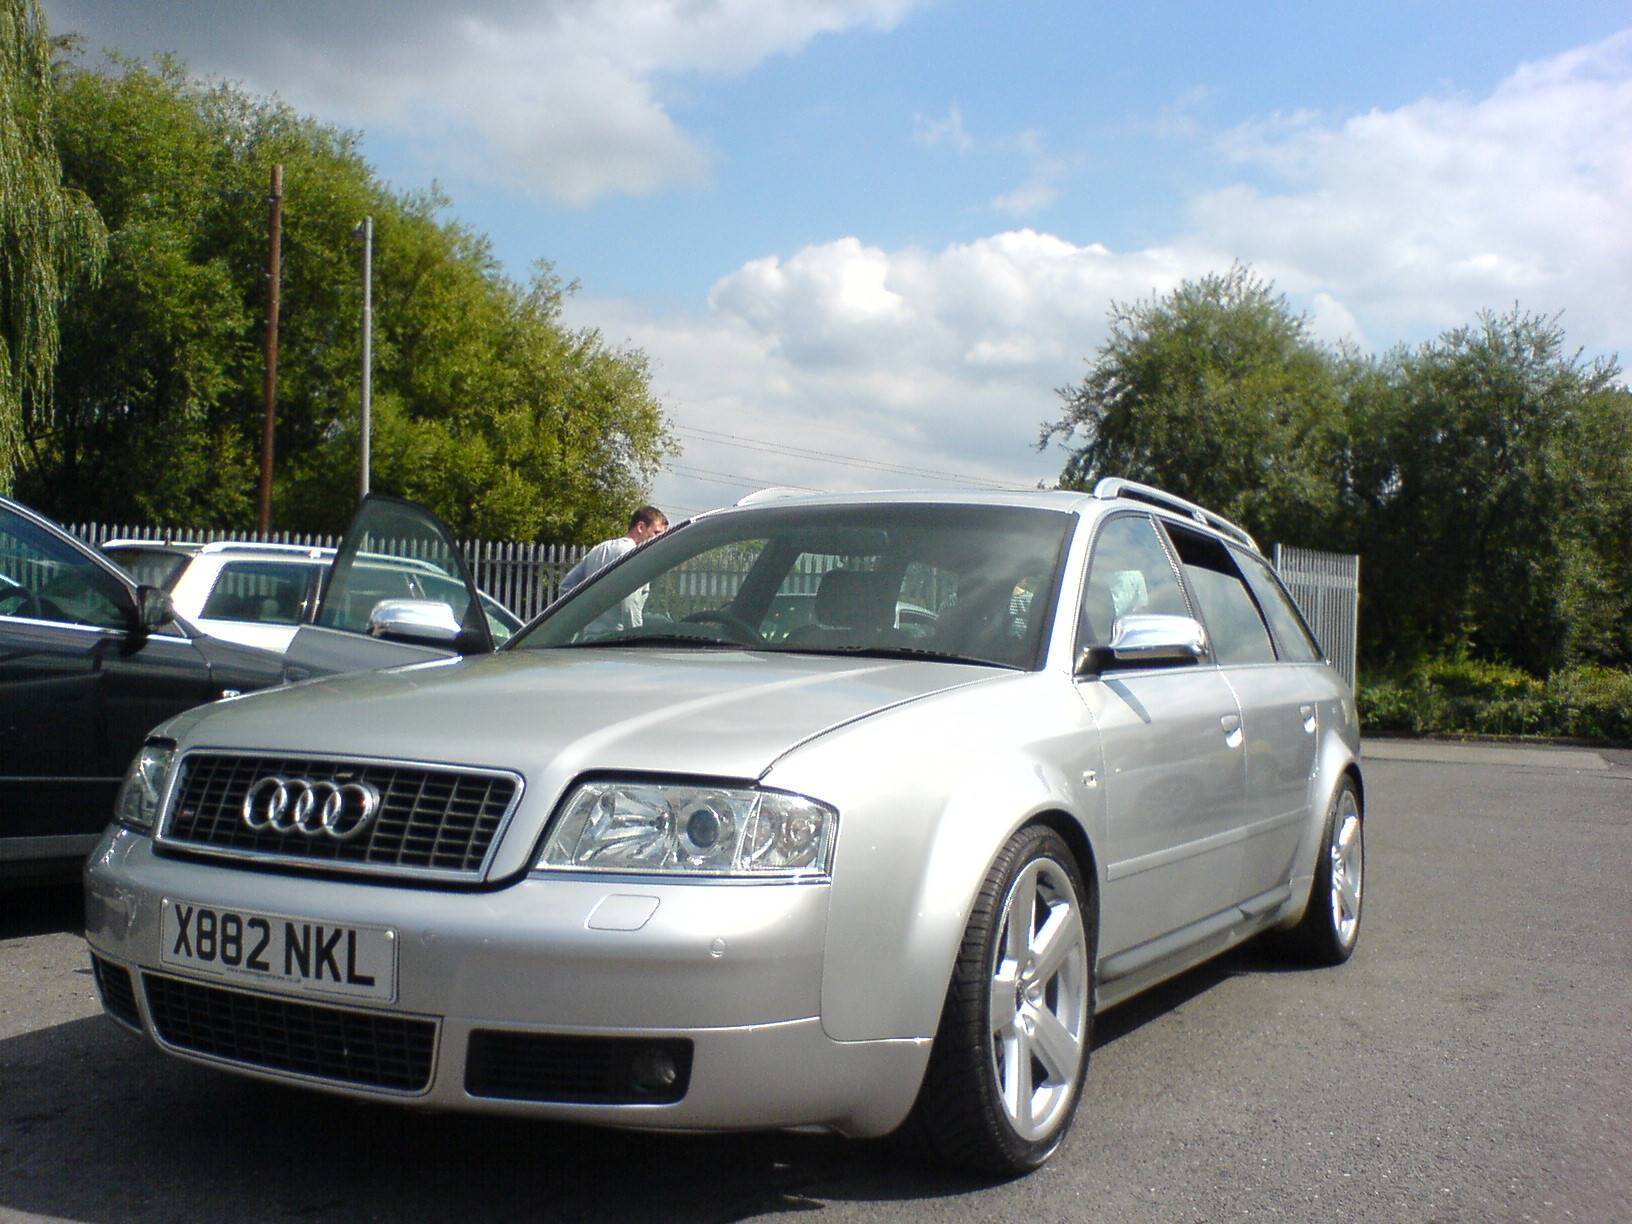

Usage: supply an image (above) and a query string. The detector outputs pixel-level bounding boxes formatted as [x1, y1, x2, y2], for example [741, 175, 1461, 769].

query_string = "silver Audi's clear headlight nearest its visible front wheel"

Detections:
[537, 782, 839, 878]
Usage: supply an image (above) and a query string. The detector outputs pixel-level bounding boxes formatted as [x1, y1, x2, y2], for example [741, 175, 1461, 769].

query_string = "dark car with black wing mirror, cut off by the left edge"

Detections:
[0, 498, 284, 878]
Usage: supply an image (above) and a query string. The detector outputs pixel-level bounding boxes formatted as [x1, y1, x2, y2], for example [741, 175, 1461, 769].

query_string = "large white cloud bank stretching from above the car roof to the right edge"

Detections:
[574, 25, 1632, 506]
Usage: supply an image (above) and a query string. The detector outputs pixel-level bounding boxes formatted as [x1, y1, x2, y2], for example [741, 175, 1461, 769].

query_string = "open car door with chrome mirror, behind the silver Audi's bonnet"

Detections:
[286, 493, 493, 679]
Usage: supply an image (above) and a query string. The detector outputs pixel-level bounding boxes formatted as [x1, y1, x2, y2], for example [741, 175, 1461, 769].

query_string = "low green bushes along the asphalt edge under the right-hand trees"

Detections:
[1356, 658, 1632, 743]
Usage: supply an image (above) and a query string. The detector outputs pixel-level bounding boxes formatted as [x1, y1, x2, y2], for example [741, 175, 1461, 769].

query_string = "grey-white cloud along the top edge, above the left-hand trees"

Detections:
[47, 0, 920, 204]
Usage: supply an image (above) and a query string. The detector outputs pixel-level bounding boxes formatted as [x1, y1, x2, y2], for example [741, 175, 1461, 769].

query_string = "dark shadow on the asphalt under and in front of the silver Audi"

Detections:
[0, 894, 1281, 1224]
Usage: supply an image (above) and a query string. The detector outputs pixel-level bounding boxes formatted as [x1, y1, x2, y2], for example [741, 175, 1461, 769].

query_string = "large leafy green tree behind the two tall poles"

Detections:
[28, 59, 672, 542]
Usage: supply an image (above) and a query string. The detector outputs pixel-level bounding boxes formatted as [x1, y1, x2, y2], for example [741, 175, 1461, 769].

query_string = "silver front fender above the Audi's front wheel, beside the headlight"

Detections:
[765, 674, 1102, 1041]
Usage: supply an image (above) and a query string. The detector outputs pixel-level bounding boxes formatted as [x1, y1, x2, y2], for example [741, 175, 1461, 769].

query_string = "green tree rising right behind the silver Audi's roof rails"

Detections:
[1040, 266, 1343, 543]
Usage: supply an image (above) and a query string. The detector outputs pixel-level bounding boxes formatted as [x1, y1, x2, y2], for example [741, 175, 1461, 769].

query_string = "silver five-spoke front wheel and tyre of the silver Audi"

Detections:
[906, 824, 1095, 1177]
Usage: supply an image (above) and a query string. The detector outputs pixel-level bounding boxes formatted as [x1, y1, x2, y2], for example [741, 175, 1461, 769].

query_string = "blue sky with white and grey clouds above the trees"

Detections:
[44, 0, 1632, 516]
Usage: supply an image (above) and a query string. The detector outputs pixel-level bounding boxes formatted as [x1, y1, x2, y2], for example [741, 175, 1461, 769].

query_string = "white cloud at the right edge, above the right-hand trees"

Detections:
[1190, 31, 1632, 348]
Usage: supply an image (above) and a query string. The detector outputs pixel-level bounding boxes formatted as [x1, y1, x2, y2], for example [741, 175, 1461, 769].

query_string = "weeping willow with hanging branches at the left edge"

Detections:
[0, 0, 106, 490]
